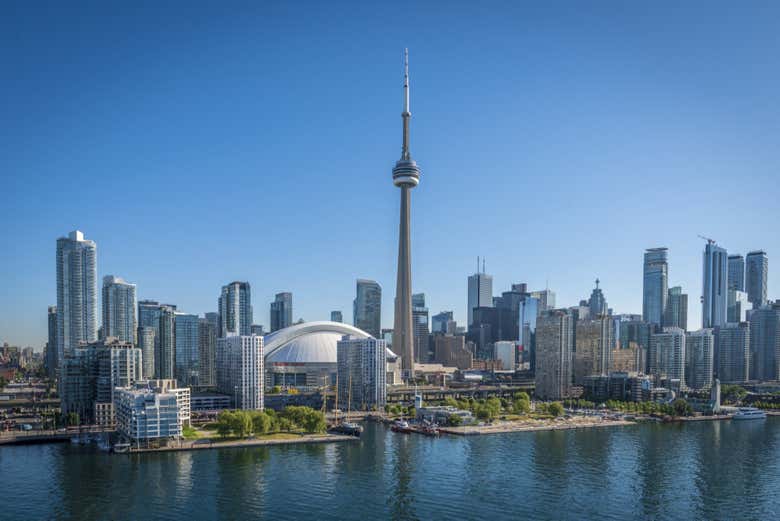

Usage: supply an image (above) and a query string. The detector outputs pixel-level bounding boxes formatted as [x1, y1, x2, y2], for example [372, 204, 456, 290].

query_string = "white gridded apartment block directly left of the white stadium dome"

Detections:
[217, 335, 265, 409]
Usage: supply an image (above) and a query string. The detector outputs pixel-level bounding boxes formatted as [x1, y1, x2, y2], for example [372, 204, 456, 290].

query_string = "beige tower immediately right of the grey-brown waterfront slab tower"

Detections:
[574, 315, 614, 385]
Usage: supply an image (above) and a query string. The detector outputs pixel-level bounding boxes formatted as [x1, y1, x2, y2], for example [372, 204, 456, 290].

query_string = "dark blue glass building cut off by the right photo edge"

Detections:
[750, 300, 780, 380]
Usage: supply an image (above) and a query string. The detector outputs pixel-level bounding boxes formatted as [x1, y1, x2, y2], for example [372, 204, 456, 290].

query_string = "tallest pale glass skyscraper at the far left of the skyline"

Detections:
[57, 230, 98, 363]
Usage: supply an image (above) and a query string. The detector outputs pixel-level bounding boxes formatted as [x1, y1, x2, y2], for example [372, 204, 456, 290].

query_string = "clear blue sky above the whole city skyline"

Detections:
[0, 2, 780, 348]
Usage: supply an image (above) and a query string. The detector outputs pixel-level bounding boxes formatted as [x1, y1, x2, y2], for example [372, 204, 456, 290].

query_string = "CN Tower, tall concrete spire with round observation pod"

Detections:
[393, 49, 420, 381]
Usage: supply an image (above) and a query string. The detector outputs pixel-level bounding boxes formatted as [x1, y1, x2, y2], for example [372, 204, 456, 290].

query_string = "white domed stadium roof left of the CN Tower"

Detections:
[263, 321, 370, 365]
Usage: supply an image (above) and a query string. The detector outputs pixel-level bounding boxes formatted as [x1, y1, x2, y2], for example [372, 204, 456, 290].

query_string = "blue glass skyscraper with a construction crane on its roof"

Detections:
[701, 239, 728, 329]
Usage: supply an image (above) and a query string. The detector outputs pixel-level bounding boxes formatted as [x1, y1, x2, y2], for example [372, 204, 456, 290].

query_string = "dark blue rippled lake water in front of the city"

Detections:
[0, 417, 780, 521]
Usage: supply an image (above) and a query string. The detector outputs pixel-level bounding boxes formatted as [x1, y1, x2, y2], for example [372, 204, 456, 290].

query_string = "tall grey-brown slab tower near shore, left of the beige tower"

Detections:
[535, 310, 574, 400]
